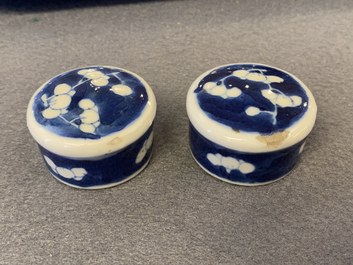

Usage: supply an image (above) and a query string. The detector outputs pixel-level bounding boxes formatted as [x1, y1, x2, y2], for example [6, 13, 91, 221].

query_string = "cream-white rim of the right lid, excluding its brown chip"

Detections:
[186, 63, 317, 153]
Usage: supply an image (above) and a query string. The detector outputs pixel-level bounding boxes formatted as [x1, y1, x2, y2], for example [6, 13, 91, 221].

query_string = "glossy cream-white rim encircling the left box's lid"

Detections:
[27, 66, 157, 159]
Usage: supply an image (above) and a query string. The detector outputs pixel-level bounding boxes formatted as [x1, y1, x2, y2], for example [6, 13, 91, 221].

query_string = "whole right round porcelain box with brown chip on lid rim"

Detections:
[186, 63, 317, 186]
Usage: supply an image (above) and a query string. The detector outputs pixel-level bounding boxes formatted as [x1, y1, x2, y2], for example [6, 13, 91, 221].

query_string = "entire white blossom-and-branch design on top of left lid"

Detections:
[41, 68, 133, 134]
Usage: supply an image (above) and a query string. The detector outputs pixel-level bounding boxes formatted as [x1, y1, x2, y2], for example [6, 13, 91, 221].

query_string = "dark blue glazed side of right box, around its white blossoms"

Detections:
[189, 123, 305, 185]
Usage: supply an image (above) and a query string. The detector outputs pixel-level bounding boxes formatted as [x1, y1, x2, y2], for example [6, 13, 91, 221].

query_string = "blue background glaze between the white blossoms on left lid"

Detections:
[33, 66, 148, 139]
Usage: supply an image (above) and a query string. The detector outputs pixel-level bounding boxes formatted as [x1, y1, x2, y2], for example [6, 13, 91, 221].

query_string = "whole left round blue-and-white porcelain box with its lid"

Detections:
[27, 66, 156, 189]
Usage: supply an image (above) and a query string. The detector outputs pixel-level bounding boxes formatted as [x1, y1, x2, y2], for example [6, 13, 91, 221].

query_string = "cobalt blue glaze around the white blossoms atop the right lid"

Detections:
[194, 64, 308, 134]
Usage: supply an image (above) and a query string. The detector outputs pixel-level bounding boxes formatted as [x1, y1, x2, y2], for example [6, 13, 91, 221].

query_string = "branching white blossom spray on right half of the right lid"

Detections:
[233, 68, 302, 124]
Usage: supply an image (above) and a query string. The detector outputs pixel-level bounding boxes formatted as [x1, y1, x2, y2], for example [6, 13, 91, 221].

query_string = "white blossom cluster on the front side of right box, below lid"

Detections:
[207, 153, 255, 174]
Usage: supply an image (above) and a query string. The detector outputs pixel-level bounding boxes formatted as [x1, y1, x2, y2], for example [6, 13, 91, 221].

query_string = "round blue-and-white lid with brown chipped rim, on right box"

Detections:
[186, 63, 317, 153]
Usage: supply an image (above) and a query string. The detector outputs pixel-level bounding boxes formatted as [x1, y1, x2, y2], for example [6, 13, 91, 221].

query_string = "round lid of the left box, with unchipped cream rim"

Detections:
[27, 66, 156, 158]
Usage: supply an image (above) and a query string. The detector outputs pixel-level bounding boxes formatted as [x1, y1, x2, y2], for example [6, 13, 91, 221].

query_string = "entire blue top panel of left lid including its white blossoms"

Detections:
[33, 67, 148, 139]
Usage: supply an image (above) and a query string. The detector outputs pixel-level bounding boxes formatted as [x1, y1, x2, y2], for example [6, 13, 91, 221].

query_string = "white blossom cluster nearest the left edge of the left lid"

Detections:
[41, 84, 75, 119]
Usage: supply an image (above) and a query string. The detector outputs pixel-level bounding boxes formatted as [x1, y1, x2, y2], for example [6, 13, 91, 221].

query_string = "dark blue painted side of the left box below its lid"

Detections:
[39, 125, 153, 188]
